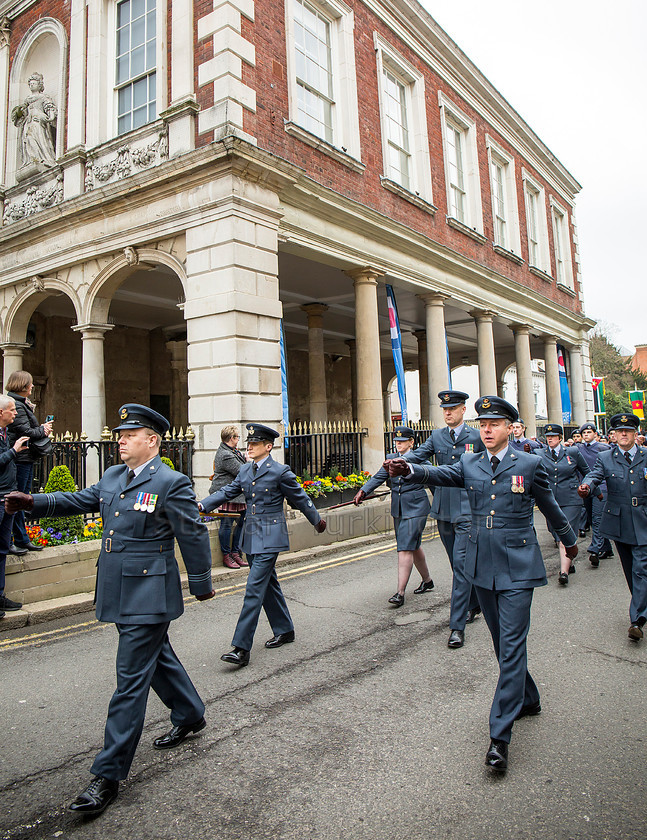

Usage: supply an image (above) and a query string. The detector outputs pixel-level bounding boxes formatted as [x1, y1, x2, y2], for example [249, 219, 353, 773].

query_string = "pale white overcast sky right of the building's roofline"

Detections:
[422, 0, 647, 353]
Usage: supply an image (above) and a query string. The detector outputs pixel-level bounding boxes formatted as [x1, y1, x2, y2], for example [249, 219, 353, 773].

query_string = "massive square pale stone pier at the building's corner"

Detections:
[184, 174, 283, 495]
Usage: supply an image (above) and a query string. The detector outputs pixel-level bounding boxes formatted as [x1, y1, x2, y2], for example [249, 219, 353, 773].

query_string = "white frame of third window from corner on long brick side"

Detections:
[438, 91, 483, 236]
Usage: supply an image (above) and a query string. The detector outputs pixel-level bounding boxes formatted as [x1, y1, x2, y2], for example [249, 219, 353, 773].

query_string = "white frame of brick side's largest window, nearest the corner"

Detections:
[285, 0, 364, 170]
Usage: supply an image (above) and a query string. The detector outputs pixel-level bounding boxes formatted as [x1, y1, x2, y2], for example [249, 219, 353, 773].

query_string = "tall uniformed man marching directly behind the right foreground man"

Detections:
[410, 391, 484, 648]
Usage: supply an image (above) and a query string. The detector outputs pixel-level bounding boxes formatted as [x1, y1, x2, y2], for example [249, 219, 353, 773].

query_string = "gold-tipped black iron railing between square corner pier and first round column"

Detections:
[284, 421, 364, 477]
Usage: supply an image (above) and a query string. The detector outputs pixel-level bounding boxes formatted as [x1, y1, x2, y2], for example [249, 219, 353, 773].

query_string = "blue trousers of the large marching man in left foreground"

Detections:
[90, 622, 204, 779]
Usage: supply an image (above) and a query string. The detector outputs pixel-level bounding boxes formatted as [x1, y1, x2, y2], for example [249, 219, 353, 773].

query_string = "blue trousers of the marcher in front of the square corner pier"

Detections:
[231, 554, 294, 650]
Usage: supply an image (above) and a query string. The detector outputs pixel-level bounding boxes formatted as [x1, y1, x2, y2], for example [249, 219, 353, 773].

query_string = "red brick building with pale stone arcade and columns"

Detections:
[0, 0, 592, 489]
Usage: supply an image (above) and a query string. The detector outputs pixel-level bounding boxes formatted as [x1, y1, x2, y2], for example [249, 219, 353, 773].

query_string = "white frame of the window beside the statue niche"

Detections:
[105, 0, 168, 140]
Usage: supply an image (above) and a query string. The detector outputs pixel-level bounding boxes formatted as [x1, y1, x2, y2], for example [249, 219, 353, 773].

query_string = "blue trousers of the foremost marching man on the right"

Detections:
[474, 586, 539, 743]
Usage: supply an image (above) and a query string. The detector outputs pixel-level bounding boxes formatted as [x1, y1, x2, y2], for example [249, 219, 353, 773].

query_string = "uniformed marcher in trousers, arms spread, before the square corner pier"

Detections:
[200, 423, 326, 666]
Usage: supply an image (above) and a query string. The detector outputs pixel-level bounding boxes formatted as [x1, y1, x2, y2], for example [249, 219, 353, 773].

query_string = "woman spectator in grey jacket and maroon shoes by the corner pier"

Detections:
[209, 426, 249, 569]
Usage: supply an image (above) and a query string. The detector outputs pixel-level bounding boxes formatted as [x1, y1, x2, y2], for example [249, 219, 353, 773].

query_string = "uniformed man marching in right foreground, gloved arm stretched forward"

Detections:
[385, 396, 577, 772]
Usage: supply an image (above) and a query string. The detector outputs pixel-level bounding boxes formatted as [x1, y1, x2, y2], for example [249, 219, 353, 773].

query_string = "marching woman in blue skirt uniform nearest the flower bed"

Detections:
[354, 426, 434, 607]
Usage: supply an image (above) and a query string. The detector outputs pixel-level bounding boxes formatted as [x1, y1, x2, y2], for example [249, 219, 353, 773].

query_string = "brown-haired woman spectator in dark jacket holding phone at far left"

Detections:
[6, 370, 52, 554]
